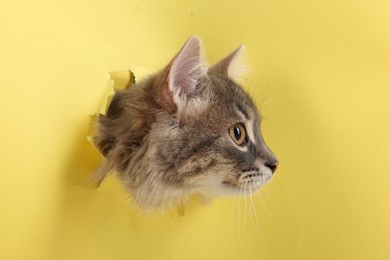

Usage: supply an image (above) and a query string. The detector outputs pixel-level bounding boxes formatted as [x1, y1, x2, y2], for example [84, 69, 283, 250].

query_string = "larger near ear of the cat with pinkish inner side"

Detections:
[168, 36, 207, 107]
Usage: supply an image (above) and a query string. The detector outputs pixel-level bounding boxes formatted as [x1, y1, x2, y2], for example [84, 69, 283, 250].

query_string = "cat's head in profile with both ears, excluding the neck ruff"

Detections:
[152, 36, 278, 195]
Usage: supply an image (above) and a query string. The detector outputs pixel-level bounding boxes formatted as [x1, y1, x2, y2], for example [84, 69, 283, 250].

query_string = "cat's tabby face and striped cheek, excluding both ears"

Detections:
[152, 75, 278, 195]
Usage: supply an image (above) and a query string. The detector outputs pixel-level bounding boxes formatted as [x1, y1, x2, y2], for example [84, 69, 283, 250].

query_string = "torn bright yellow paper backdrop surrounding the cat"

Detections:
[0, 0, 390, 259]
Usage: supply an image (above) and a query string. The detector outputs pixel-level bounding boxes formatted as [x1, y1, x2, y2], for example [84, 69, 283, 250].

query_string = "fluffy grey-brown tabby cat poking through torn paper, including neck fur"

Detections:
[93, 36, 278, 209]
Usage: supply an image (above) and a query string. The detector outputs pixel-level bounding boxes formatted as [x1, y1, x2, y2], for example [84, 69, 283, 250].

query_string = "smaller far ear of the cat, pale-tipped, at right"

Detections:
[210, 45, 249, 81]
